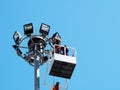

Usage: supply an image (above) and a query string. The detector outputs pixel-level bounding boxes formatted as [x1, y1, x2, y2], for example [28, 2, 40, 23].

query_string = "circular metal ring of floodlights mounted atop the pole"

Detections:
[13, 23, 50, 65]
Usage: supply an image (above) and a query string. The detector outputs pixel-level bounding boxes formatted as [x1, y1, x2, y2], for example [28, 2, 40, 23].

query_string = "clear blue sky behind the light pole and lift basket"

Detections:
[0, 0, 120, 90]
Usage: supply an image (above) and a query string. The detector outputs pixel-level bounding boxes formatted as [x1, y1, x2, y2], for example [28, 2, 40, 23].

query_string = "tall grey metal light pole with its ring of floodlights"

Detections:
[13, 23, 50, 90]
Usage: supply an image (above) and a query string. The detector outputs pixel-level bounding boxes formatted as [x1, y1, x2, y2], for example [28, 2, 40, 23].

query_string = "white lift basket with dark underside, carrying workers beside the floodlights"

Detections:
[49, 45, 76, 79]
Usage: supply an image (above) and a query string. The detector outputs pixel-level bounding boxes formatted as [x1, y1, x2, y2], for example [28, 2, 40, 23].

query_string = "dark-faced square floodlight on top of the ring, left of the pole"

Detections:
[23, 23, 33, 36]
